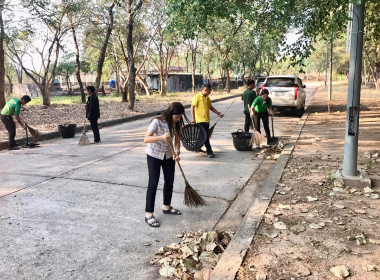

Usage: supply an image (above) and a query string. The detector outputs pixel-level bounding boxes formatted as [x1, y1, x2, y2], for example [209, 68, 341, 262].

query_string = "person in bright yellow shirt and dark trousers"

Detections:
[191, 84, 224, 158]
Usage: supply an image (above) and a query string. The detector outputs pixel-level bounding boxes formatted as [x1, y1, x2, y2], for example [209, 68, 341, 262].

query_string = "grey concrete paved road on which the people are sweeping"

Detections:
[0, 84, 313, 280]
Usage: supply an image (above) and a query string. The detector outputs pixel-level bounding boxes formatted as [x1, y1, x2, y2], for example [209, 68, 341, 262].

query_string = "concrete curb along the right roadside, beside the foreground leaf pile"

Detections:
[209, 91, 318, 280]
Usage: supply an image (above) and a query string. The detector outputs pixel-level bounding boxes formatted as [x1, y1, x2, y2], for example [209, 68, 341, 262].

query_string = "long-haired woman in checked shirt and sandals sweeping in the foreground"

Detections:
[144, 102, 185, 227]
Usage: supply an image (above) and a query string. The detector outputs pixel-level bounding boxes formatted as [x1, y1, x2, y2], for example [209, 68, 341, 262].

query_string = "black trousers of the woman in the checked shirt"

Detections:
[145, 155, 175, 213]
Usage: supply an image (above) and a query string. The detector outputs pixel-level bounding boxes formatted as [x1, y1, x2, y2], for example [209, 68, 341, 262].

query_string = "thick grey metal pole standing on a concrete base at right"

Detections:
[342, 0, 365, 176]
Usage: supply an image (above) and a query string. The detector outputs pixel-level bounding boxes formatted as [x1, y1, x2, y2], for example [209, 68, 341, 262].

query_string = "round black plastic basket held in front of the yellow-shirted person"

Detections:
[181, 124, 207, 152]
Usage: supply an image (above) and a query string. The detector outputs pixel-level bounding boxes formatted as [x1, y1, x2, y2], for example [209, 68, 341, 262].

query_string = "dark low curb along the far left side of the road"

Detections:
[0, 94, 241, 151]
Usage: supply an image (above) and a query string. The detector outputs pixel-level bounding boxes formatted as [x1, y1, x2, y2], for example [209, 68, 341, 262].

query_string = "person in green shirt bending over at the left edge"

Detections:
[0, 95, 31, 150]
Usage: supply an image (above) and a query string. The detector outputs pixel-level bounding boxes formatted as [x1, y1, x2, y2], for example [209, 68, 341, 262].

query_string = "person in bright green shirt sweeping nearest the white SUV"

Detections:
[252, 88, 273, 138]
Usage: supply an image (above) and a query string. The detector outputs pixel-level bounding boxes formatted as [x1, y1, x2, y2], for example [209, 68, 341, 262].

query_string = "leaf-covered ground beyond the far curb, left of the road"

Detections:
[0, 89, 235, 142]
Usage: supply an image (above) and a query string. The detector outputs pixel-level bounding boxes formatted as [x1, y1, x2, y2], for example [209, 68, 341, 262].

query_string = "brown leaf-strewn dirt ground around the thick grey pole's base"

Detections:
[236, 85, 380, 280]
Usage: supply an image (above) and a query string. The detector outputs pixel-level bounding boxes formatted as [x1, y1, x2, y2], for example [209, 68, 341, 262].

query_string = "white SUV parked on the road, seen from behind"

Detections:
[261, 75, 306, 116]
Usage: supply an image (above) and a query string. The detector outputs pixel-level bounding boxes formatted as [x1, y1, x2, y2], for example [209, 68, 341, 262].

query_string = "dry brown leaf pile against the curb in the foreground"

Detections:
[150, 230, 233, 280]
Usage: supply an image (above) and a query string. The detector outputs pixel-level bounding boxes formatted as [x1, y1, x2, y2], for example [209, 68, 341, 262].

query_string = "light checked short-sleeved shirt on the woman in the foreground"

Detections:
[145, 119, 173, 160]
